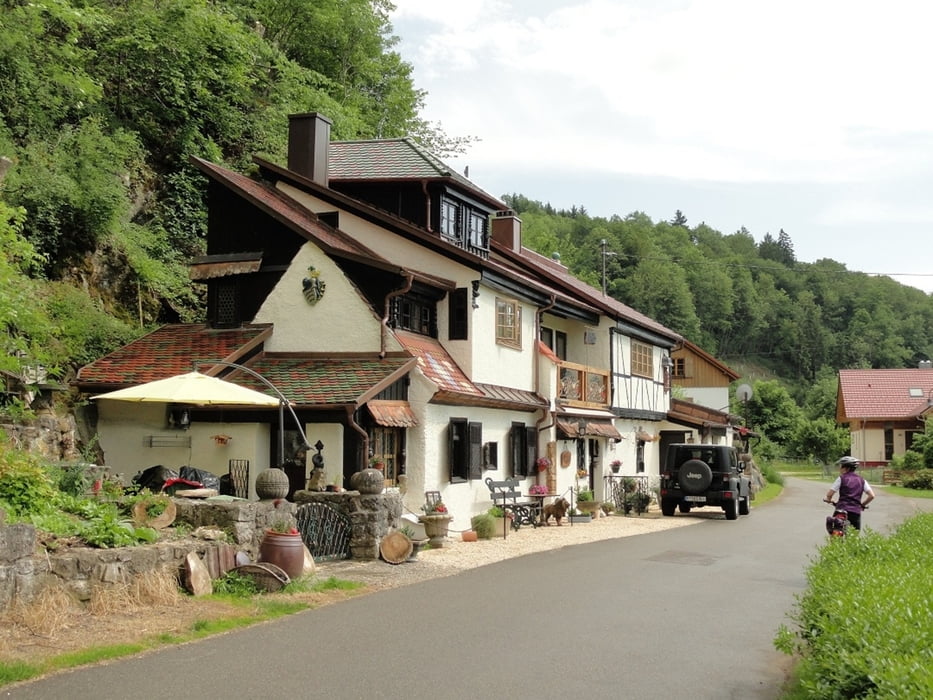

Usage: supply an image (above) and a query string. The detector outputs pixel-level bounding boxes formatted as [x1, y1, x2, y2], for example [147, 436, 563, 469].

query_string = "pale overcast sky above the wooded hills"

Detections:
[391, 0, 933, 293]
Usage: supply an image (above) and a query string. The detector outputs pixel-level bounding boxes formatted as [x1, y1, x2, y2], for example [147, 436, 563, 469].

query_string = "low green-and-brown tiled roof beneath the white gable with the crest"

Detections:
[229, 354, 415, 408]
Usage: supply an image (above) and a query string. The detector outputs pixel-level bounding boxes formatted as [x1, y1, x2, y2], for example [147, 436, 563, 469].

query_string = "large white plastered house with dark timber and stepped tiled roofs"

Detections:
[77, 114, 682, 529]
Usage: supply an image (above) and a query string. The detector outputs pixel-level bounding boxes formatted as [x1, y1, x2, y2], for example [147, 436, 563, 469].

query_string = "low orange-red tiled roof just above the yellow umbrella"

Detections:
[77, 323, 272, 391]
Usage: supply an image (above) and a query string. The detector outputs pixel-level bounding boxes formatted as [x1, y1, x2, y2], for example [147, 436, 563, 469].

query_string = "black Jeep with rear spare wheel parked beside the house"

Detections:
[661, 443, 751, 520]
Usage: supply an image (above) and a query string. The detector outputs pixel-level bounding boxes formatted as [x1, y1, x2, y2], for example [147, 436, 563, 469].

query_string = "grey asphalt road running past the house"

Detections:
[7, 479, 933, 700]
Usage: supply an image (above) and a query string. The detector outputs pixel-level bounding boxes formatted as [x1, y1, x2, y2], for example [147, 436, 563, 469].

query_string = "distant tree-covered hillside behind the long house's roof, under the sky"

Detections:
[505, 194, 933, 384]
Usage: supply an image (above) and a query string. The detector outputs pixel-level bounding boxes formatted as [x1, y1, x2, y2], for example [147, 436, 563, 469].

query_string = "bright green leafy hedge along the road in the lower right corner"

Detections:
[775, 513, 933, 698]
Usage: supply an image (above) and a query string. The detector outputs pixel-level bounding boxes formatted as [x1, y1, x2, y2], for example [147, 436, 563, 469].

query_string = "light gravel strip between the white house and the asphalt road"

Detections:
[317, 511, 701, 589]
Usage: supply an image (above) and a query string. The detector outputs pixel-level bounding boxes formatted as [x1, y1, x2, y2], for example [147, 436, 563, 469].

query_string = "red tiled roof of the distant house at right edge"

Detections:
[837, 369, 933, 421]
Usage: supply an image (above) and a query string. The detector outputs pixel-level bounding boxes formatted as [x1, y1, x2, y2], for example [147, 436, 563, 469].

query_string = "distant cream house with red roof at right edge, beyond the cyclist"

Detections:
[836, 362, 933, 467]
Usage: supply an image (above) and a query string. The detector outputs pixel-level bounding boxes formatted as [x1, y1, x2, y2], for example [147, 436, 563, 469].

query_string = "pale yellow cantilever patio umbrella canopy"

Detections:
[92, 372, 281, 407]
